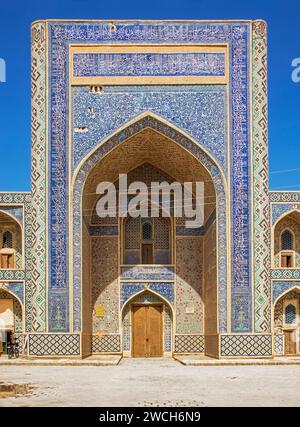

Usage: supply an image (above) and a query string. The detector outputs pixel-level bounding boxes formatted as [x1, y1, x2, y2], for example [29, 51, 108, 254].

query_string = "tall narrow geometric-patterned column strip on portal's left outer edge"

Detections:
[31, 22, 48, 332]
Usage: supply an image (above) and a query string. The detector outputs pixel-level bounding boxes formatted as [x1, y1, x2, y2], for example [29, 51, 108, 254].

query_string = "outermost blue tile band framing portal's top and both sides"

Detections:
[48, 21, 252, 331]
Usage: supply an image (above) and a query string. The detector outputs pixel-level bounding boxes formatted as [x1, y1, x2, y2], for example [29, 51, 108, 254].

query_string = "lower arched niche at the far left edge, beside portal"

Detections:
[0, 288, 23, 354]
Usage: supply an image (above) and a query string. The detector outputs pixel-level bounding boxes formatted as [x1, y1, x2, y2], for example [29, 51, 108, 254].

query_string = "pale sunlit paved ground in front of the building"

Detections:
[0, 359, 300, 406]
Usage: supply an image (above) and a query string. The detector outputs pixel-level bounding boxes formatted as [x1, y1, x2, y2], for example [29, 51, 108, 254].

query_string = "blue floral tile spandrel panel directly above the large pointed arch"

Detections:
[72, 85, 227, 173]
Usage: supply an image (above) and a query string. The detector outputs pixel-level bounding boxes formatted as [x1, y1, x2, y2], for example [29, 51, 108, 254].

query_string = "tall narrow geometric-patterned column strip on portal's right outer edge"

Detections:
[252, 21, 271, 332]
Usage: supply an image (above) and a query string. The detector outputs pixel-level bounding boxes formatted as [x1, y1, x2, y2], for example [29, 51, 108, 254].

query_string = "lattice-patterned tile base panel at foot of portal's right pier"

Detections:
[221, 334, 272, 357]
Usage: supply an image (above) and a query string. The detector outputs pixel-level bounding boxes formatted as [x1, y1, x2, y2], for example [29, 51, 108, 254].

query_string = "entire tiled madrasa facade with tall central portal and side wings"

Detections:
[0, 20, 300, 358]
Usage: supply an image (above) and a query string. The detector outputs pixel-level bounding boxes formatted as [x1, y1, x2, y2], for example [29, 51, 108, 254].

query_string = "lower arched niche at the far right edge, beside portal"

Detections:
[274, 286, 300, 356]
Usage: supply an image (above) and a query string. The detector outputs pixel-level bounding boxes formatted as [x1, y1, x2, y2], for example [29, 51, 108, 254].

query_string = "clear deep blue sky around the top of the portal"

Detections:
[0, 0, 300, 191]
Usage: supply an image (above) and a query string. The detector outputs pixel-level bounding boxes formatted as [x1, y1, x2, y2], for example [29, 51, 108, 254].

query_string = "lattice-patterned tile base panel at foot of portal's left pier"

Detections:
[29, 334, 80, 356]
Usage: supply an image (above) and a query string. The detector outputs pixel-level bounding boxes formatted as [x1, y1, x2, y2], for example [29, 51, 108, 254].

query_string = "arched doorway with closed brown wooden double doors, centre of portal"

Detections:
[122, 290, 173, 357]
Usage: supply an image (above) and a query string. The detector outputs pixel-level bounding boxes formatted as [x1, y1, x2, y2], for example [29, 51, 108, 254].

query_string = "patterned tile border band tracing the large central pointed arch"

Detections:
[69, 112, 230, 338]
